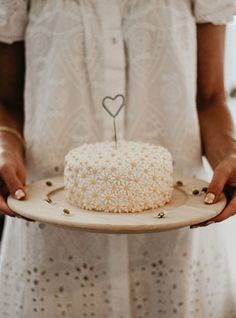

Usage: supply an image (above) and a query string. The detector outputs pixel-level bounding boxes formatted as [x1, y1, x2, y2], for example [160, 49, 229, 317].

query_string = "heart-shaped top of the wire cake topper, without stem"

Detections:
[102, 94, 125, 118]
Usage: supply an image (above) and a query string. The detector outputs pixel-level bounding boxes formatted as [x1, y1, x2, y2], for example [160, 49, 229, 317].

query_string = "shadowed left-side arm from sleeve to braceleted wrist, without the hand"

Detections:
[0, 42, 25, 151]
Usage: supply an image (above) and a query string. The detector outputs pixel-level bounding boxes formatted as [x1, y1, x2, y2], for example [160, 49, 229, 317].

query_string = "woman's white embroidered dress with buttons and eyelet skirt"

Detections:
[0, 0, 236, 318]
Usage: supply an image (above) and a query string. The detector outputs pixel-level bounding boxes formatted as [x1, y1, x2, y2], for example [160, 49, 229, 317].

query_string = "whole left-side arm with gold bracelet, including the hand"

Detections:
[0, 42, 26, 211]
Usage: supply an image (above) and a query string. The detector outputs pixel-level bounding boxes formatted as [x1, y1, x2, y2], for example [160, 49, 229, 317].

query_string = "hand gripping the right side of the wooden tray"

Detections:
[193, 155, 236, 227]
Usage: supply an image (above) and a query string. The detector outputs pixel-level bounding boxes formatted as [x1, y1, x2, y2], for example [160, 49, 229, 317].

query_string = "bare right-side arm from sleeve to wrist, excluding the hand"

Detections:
[197, 23, 236, 168]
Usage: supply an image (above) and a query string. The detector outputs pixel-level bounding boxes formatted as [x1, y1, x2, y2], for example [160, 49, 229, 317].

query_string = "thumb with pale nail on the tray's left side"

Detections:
[1, 165, 26, 200]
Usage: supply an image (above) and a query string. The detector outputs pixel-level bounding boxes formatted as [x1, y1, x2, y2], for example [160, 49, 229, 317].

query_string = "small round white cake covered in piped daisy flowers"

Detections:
[64, 141, 173, 212]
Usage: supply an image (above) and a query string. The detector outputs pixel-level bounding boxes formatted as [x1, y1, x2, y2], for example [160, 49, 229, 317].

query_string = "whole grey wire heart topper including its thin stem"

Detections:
[102, 94, 125, 148]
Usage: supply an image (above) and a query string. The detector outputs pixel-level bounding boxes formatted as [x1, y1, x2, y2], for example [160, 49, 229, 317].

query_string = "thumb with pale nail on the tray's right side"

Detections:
[204, 166, 230, 204]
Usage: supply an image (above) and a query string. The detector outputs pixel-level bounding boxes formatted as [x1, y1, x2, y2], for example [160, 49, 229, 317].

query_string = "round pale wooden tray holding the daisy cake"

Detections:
[8, 176, 226, 233]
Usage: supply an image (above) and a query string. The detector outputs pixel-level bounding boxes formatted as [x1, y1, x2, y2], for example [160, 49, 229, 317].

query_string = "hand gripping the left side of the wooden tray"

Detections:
[0, 133, 26, 217]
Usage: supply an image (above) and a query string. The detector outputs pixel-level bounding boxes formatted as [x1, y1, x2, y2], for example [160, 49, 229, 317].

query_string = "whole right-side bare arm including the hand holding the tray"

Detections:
[194, 23, 236, 227]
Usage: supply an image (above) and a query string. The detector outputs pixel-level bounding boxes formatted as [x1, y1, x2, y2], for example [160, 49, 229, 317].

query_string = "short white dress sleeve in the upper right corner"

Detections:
[194, 0, 236, 24]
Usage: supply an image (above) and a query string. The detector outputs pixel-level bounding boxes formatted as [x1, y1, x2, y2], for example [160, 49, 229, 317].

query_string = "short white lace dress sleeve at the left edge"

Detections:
[0, 0, 28, 43]
